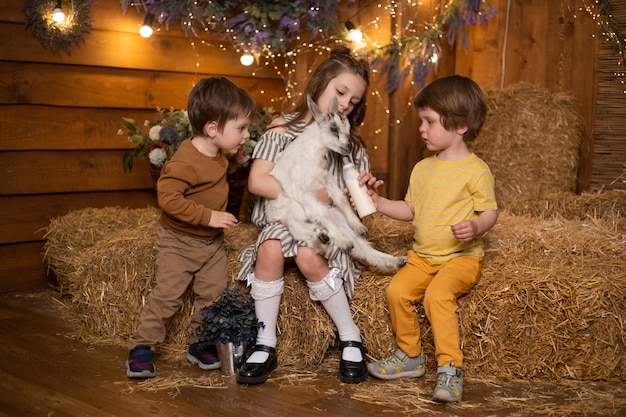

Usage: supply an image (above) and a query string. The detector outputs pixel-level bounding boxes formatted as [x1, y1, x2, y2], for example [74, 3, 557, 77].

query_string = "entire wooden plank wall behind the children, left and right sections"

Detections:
[0, 0, 621, 292]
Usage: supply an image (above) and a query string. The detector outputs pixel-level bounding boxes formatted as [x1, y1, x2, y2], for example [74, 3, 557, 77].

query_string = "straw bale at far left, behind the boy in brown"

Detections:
[44, 207, 192, 352]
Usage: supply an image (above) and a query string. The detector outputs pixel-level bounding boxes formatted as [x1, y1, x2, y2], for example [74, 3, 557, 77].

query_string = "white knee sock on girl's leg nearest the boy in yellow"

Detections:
[307, 268, 363, 362]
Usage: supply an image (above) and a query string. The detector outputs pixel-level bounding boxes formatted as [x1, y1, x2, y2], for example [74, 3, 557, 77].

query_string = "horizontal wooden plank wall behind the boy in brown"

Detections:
[0, 0, 284, 292]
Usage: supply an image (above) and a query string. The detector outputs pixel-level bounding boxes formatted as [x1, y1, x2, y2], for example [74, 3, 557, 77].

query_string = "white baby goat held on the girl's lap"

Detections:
[265, 97, 405, 270]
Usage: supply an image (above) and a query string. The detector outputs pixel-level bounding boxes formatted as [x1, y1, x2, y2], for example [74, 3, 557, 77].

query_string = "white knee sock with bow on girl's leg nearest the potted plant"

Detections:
[246, 274, 284, 363]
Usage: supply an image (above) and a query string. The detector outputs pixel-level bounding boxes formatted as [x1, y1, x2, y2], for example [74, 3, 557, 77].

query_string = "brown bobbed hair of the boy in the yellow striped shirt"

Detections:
[413, 75, 487, 142]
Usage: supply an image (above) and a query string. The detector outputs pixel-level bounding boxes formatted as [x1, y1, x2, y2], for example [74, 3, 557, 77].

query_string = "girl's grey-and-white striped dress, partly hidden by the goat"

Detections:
[237, 115, 370, 298]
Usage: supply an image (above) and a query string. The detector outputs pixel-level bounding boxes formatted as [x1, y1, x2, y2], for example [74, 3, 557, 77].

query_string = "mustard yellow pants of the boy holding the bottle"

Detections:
[386, 251, 480, 368]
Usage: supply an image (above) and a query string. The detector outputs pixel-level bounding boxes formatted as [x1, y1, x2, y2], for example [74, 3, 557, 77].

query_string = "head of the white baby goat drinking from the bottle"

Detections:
[307, 96, 352, 155]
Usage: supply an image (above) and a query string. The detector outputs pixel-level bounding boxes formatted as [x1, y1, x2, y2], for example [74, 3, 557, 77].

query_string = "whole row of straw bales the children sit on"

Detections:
[45, 190, 626, 380]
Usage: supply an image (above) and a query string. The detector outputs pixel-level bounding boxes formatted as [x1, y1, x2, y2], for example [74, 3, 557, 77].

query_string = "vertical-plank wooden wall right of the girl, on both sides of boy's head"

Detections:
[362, 0, 608, 198]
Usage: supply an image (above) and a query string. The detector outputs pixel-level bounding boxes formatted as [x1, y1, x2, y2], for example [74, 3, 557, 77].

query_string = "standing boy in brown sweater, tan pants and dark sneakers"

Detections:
[126, 77, 256, 378]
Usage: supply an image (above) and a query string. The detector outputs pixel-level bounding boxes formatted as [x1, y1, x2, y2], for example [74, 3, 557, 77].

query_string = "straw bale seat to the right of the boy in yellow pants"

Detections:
[458, 213, 626, 380]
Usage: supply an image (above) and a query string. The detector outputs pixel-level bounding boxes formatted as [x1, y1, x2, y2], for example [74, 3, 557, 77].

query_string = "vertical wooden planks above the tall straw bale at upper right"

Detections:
[456, 0, 599, 191]
